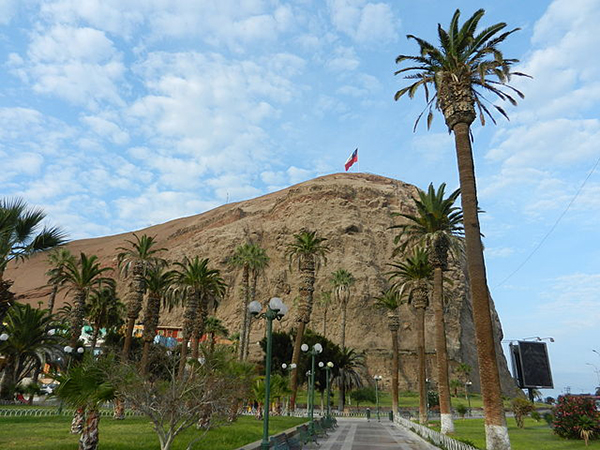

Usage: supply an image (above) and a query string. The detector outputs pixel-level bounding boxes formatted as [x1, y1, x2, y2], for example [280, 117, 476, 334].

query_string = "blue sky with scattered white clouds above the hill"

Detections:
[0, 0, 600, 395]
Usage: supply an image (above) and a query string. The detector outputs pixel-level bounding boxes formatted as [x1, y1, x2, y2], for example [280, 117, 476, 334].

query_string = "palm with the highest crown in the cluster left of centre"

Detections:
[117, 233, 166, 360]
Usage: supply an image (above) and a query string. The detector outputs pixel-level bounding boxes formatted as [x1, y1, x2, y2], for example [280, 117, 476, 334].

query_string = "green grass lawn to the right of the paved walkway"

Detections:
[432, 417, 600, 450]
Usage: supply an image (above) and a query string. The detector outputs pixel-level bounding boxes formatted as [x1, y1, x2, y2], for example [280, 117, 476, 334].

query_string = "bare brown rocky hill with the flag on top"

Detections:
[6, 174, 514, 393]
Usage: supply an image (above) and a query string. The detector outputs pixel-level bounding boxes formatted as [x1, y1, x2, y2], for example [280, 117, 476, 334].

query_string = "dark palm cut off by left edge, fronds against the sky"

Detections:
[0, 198, 66, 323]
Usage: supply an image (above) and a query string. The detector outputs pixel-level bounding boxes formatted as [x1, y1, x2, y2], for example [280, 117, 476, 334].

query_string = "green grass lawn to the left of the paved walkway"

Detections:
[0, 416, 306, 450]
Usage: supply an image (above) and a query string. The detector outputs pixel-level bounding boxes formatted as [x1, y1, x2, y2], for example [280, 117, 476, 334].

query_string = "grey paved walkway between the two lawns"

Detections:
[318, 418, 439, 450]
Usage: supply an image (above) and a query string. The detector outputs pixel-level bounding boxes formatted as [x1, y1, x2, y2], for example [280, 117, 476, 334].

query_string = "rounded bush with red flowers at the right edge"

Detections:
[552, 395, 600, 439]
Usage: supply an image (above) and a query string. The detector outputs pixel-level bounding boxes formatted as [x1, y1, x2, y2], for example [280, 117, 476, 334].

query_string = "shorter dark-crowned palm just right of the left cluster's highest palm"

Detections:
[140, 263, 175, 374]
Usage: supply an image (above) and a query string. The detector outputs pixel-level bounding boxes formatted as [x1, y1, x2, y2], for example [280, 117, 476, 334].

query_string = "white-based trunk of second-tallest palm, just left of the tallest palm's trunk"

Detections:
[432, 266, 454, 434]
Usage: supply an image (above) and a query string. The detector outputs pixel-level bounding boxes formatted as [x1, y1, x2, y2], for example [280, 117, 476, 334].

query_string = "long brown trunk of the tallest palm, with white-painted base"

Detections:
[453, 123, 511, 450]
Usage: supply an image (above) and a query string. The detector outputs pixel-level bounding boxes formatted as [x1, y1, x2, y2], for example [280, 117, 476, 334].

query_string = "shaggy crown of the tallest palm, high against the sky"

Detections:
[394, 9, 527, 129]
